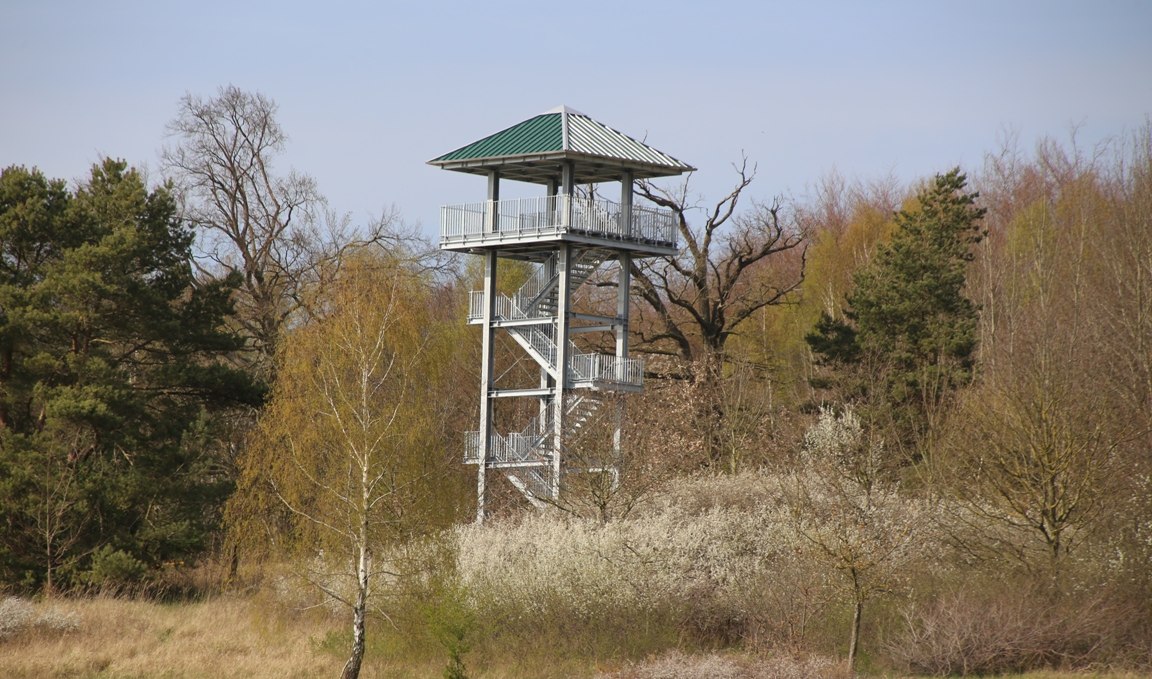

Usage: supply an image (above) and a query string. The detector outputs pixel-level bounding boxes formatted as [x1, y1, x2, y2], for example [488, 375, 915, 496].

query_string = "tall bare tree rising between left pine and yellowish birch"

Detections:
[164, 85, 405, 372]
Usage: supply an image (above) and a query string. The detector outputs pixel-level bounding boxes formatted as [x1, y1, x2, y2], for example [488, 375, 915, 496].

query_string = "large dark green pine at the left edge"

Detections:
[0, 159, 260, 593]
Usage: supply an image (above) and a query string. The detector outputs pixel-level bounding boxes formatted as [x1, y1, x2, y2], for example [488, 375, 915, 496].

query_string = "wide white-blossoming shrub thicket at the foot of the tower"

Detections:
[454, 465, 857, 647]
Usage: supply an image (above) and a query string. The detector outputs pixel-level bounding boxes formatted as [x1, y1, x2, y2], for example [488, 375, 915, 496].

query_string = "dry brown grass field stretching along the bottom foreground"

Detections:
[0, 595, 1152, 679]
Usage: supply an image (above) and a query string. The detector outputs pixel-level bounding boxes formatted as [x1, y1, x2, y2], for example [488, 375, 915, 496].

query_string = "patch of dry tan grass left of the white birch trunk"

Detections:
[0, 598, 341, 679]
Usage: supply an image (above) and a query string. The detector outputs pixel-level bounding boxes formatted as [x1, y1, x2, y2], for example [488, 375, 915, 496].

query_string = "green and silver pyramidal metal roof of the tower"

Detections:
[429, 106, 695, 183]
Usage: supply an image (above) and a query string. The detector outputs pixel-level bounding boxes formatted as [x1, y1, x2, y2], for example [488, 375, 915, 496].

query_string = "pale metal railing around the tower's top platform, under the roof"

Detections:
[440, 195, 676, 247]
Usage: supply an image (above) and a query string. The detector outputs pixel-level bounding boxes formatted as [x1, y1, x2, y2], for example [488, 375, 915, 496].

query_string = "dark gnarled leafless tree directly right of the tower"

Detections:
[631, 161, 806, 463]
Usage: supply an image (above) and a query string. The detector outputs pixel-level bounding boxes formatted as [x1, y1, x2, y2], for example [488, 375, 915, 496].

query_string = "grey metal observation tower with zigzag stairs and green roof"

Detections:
[429, 106, 695, 522]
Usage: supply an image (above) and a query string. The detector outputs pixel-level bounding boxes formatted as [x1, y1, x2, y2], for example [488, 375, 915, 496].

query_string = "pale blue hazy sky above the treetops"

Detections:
[0, 0, 1152, 235]
